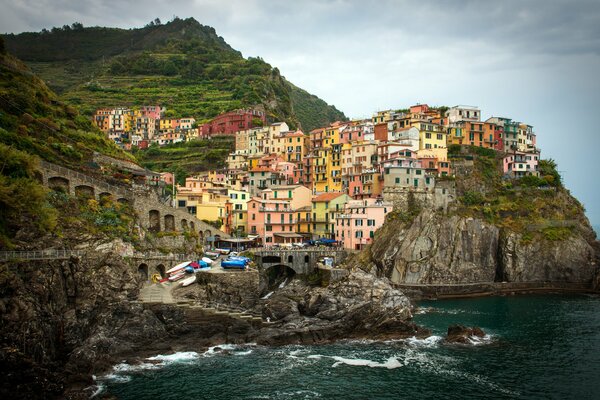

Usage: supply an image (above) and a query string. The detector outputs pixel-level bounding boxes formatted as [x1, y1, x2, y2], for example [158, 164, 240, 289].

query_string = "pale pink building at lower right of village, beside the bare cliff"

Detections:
[335, 199, 393, 250]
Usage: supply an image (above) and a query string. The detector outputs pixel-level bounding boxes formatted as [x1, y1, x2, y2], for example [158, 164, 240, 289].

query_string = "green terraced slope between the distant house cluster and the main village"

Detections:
[134, 136, 235, 184]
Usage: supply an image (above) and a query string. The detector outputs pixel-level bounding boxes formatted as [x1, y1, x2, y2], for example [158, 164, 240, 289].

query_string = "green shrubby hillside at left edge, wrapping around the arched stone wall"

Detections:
[0, 40, 142, 249]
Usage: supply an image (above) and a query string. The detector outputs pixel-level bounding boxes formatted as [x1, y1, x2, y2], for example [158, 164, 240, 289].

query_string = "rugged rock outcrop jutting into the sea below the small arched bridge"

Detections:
[257, 270, 429, 344]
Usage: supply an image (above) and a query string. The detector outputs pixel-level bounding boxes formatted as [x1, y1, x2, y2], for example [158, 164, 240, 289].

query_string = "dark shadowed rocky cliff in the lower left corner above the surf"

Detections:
[0, 252, 164, 398]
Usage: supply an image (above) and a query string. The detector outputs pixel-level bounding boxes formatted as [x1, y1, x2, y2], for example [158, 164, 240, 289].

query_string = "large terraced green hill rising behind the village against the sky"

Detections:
[4, 18, 346, 131]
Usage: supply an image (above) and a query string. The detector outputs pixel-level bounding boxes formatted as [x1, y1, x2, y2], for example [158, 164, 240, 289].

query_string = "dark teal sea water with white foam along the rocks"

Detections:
[99, 295, 600, 399]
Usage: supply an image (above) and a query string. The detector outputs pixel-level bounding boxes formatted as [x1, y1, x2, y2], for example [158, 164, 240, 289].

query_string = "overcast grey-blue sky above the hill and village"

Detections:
[0, 0, 600, 226]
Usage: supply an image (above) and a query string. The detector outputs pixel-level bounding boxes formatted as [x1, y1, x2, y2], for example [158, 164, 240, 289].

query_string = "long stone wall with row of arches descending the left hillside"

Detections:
[38, 161, 230, 240]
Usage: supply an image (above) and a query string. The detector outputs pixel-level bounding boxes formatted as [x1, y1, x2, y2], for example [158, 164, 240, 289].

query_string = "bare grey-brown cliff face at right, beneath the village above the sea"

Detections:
[370, 210, 596, 284]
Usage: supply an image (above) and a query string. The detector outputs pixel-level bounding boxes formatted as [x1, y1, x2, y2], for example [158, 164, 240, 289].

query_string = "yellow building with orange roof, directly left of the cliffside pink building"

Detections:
[311, 193, 350, 239]
